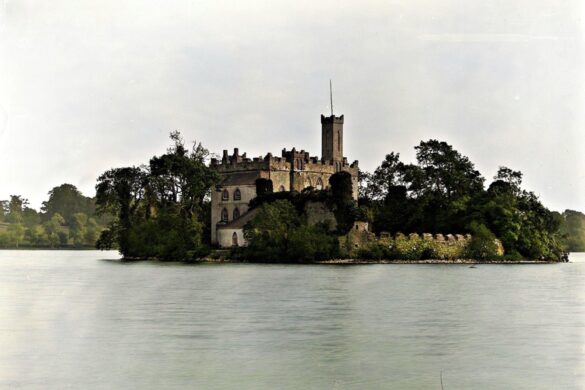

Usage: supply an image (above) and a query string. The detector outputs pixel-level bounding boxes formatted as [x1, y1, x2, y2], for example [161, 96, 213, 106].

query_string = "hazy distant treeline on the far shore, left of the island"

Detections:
[0, 184, 111, 248]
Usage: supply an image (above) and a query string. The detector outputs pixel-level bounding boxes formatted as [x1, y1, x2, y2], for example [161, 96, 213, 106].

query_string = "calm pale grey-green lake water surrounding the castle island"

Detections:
[0, 251, 585, 390]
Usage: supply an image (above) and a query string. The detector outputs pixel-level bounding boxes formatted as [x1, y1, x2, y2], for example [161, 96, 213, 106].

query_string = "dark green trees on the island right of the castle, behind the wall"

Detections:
[360, 140, 563, 259]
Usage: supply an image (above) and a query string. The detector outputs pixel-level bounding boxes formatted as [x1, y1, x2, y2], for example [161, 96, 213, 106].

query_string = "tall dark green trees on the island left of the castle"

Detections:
[96, 132, 218, 260]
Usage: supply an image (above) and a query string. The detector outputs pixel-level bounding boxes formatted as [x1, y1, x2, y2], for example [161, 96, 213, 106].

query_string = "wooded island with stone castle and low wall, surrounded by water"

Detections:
[89, 115, 568, 263]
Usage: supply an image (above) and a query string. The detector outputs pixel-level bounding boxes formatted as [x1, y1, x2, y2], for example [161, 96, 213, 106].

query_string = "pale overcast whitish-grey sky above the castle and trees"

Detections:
[0, 0, 585, 211]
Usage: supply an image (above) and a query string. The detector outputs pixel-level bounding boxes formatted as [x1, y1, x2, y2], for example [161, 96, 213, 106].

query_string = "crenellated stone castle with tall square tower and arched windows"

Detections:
[211, 115, 358, 247]
